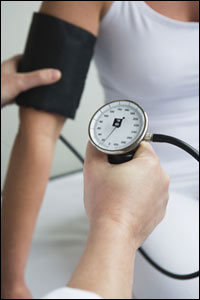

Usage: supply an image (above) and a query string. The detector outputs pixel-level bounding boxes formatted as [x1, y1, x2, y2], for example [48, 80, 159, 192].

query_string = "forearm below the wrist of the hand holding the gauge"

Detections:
[68, 222, 136, 299]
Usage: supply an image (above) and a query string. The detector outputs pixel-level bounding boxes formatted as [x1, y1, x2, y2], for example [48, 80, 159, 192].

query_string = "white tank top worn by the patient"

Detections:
[94, 1, 199, 181]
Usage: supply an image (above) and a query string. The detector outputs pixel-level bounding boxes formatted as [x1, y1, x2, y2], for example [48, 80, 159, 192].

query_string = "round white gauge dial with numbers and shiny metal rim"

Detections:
[89, 100, 148, 154]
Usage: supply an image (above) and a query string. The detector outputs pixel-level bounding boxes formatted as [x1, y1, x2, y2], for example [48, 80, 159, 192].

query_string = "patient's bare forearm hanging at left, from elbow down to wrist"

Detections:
[1, 134, 55, 284]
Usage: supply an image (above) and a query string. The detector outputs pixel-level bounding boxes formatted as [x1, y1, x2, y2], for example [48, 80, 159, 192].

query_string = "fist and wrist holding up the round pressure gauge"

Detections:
[68, 142, 169, 299]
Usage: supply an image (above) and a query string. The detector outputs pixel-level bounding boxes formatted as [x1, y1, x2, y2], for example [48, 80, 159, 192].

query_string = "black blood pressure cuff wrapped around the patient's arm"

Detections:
[16, 13, 96, 119]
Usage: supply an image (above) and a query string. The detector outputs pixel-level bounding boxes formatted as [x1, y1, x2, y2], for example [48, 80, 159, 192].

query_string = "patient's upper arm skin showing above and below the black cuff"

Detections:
[20, 1, 104, 139]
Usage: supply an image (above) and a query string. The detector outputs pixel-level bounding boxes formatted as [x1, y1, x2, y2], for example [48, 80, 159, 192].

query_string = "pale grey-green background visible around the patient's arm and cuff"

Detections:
[1, 1, 103, 187]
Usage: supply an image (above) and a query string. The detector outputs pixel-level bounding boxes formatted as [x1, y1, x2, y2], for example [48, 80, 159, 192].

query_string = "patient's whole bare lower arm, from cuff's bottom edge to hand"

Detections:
[1, 108, 65, 299]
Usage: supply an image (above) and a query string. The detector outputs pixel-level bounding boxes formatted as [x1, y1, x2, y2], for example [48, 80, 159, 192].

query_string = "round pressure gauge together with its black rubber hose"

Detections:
[88, 100, 199, 280]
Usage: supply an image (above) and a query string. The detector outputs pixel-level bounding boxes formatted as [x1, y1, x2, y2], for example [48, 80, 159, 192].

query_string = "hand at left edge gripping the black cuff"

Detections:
[1, 55, 61, 107]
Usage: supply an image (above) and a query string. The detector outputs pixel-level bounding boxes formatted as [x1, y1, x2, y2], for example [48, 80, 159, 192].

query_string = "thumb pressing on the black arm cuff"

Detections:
[17, 69, 61, 92]
